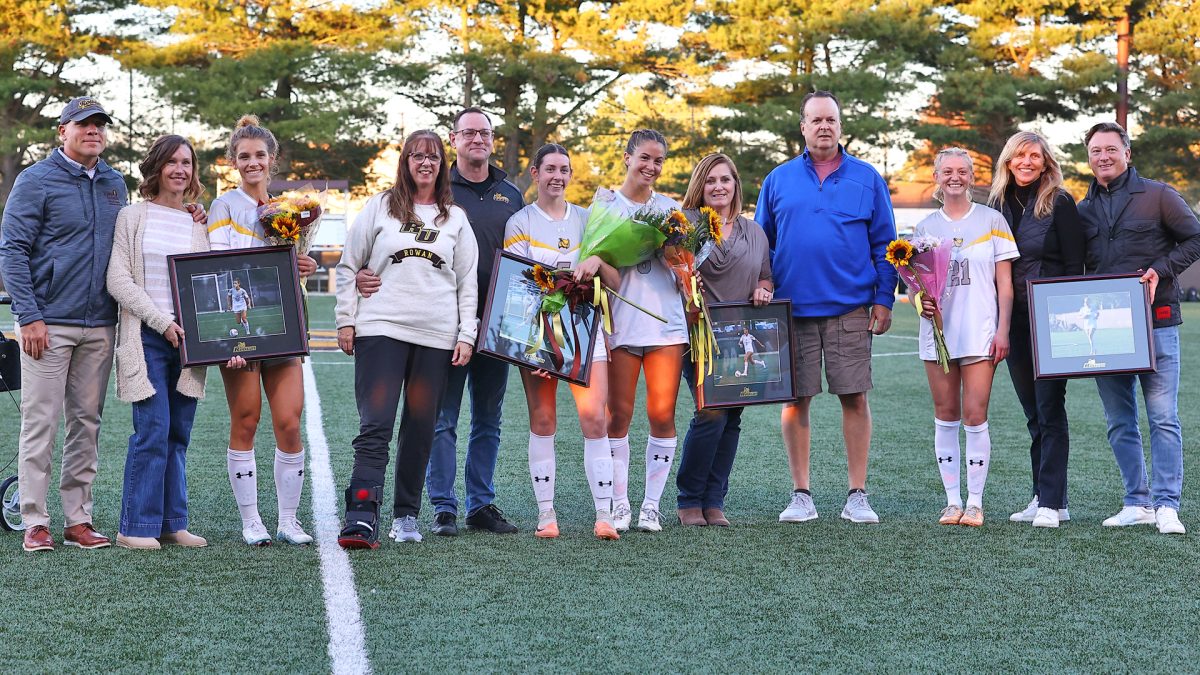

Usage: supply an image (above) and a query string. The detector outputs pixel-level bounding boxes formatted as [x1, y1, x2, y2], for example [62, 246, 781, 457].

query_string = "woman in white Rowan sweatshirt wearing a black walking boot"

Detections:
[337, 130, 479, 549]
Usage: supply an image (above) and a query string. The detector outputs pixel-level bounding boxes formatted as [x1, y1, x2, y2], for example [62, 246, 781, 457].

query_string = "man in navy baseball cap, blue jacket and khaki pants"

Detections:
[0, 96, 205, 551]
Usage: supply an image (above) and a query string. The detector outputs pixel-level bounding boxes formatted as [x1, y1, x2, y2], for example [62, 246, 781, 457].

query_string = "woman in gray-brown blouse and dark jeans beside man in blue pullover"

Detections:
[676, 154, 774, 526]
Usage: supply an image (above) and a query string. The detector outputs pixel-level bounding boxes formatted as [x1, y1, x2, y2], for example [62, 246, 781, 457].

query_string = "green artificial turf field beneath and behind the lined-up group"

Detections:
[0, 298, 1200, 674]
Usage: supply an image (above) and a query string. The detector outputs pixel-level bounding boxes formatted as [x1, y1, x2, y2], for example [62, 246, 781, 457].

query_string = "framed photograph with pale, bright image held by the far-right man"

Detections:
[1026, 273, 1156, 380]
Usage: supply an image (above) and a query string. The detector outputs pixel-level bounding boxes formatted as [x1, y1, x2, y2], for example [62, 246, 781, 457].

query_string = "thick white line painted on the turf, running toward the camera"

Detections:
[304, 360, 371, 675]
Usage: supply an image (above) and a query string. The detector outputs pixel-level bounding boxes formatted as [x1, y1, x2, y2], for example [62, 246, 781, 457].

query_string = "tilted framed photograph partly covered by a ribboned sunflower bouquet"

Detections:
[475, 251, 604, 387]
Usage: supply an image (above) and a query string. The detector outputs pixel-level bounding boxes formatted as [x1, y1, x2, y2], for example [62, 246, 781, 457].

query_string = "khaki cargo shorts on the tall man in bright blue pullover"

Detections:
[792, 307, 874, 396]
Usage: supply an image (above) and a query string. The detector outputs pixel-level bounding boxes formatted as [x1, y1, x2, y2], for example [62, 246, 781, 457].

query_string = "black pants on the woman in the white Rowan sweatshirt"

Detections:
[352, 335, 452, 518]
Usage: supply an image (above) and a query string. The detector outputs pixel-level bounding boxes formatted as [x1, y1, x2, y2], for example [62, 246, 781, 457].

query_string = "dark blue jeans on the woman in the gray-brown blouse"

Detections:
[676, 357, 745, 510]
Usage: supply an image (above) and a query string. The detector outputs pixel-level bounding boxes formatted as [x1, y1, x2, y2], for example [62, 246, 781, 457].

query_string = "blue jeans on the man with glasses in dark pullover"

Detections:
[425, 354, 509, 515]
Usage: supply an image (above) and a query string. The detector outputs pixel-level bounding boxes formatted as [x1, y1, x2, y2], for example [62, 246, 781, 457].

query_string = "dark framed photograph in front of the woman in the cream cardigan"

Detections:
[167, 246, 308, 368]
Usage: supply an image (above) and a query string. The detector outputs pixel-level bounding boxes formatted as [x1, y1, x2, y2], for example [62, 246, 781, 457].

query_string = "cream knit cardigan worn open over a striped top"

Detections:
[108, 202, 209, 402]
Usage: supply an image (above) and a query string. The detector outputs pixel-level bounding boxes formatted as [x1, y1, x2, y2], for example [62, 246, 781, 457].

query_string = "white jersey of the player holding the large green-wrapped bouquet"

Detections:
[611, 191, 688, 348]
